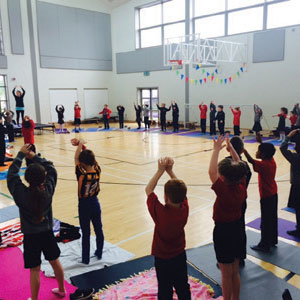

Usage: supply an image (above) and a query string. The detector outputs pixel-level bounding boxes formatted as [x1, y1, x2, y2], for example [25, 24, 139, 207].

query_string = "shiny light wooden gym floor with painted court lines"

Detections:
[0, 124, 300, 288]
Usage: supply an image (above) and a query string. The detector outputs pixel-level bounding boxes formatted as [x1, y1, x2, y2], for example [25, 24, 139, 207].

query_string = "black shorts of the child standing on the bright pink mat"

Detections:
[23, 230, 60, 269]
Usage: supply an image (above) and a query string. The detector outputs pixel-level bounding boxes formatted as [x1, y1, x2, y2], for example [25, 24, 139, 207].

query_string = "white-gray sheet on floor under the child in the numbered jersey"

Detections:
[19, 236, 135, 280]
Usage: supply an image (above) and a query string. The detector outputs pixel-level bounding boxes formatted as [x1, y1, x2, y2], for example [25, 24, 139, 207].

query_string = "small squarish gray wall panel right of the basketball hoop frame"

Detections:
[253, 29, 285, 63]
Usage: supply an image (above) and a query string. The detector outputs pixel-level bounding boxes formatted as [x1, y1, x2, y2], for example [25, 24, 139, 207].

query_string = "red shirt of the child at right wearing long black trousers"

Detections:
[254, 158, 277, 198]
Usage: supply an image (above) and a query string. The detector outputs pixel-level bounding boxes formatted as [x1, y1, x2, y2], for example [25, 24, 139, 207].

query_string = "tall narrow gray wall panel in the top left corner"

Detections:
[7, 0, 24, 54]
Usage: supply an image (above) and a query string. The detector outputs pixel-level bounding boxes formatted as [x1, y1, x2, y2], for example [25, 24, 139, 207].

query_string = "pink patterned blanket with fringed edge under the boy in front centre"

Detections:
[95, 269, 223, 300]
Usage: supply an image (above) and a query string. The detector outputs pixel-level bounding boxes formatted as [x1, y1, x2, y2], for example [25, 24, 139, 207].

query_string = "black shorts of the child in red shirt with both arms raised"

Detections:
[213, 219, 245, 264]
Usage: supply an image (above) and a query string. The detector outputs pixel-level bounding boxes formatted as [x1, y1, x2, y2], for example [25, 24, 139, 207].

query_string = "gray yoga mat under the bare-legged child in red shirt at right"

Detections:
[187, 244, 300, 300]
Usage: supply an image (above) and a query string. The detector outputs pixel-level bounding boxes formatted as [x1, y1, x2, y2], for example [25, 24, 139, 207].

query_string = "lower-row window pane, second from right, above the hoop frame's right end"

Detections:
[228, 7, 264, 34]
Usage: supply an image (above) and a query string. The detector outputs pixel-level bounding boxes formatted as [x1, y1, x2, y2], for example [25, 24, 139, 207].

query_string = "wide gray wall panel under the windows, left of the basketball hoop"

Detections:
[116, 46, 169, 74]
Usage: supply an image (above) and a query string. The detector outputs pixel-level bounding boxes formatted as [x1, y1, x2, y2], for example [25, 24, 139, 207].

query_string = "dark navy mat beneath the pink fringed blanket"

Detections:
[71, 256, 222, 297]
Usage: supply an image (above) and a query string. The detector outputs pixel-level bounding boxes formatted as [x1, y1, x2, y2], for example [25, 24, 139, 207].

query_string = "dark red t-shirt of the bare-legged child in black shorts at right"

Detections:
[211, 178, 247, 223]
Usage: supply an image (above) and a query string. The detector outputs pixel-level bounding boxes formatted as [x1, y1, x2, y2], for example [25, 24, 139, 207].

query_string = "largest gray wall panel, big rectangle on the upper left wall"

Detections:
[37, 1, 112, 71]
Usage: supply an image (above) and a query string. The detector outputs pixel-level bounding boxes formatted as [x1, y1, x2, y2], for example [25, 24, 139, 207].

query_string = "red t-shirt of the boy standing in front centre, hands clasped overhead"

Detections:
[147, 193, 189, 259]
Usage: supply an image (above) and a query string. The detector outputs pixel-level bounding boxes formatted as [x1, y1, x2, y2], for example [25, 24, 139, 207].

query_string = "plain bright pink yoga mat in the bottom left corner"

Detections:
[0, 247, 76, 300]
